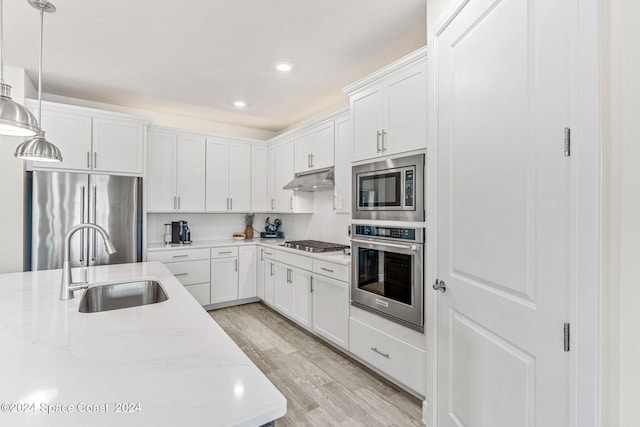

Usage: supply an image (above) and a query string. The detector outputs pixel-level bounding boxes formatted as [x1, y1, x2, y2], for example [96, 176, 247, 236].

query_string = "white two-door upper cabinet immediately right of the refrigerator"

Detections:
[147, 128, 205, 212]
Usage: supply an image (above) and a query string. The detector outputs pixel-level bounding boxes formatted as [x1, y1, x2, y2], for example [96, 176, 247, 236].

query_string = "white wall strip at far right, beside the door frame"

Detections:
[601, 0, 640, 427]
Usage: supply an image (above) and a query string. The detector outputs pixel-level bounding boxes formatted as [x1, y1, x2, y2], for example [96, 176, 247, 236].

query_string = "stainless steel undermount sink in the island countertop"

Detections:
[79, 280, 169, 313]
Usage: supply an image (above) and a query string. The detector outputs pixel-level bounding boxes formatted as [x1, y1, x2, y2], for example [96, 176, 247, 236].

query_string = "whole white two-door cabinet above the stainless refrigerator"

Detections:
[27, 100, 149, 175]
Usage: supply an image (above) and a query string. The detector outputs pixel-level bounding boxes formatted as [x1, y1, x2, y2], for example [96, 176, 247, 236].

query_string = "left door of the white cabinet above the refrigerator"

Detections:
[33, 106, 92, 171]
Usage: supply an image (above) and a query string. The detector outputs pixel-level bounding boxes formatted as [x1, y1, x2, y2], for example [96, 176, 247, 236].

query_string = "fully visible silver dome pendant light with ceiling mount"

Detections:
[14, 0, 62, 162]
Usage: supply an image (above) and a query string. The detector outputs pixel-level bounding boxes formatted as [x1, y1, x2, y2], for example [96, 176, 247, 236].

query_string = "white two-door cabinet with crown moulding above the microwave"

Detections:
[346, 48, 427, 161]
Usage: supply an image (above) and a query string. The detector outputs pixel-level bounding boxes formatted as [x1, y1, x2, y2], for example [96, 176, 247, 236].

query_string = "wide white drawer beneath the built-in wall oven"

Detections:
[349, 318, 426, 394]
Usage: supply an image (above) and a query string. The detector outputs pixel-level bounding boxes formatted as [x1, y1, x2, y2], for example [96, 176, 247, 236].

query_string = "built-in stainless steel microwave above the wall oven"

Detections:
[351, 154, 425, 221]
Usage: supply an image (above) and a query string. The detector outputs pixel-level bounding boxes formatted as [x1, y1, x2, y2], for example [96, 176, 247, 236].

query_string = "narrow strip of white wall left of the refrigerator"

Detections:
[0, 67, 30, 273]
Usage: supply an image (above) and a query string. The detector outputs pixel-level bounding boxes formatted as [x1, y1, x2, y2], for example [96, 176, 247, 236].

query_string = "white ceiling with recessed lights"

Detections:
[4, 0, 426, 132]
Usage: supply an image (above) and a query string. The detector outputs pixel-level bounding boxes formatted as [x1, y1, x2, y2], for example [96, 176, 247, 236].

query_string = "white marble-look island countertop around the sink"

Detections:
[0, 263, 287, 427]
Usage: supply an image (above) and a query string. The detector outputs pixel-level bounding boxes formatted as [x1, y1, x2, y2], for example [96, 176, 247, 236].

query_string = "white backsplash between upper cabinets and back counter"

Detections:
[147, 191, 351, 245]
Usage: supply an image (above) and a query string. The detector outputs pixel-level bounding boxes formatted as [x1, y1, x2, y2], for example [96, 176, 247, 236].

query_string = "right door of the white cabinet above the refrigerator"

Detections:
[93, 117, 144, 175]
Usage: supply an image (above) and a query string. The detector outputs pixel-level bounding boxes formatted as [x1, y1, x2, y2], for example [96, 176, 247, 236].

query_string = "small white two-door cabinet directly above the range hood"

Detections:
[295, 120, 334, 173]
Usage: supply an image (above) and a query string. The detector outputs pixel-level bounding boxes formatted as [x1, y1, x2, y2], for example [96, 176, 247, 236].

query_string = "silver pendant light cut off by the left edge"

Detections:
[0, 0, 40, 136]
